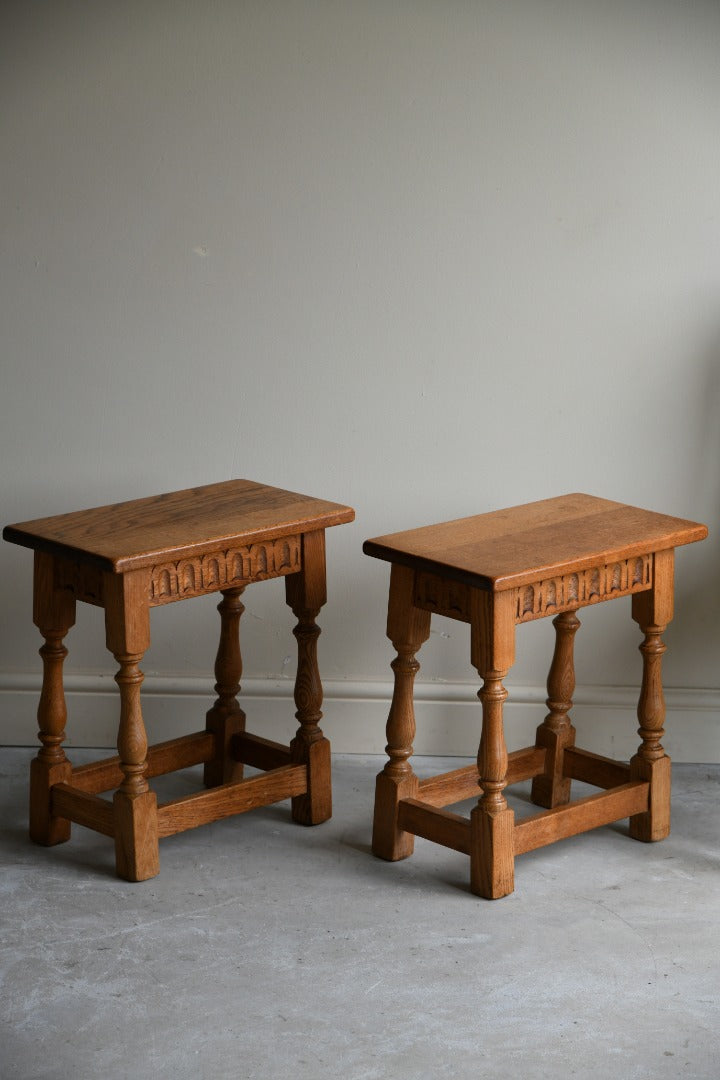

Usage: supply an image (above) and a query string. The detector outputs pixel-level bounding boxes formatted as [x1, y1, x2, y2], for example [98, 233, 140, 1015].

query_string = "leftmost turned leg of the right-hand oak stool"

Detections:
[372, 564, 430, 861]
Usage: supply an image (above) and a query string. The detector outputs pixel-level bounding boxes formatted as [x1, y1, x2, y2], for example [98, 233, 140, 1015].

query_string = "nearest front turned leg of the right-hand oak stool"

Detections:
[470, 592, 515, 900]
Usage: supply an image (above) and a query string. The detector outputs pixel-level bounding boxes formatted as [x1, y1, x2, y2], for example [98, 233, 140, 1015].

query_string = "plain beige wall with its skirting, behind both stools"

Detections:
[0, 0, 720, 760]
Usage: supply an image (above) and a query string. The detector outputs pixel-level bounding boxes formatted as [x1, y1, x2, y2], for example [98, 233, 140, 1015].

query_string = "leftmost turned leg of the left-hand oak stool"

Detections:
[30, 552, 76, 847]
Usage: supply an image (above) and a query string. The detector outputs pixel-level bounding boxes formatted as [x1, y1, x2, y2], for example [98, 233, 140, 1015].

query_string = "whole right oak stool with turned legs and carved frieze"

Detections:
[364, 495, 707, 900]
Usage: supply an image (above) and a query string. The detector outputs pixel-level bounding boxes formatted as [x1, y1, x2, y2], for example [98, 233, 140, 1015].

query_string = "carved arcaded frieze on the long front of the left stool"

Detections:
[150, 536, 302, 605]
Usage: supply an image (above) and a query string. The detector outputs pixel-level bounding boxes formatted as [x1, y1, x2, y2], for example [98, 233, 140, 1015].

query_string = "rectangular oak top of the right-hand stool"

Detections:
[363, 495, 707, 592]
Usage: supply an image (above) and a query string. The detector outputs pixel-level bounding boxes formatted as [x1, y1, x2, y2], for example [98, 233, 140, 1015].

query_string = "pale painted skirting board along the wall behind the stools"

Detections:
[0, 674, 720, 764]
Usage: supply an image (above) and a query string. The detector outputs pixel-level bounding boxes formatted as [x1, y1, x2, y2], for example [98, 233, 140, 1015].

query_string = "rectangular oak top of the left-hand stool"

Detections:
[2, 480, 355, 573]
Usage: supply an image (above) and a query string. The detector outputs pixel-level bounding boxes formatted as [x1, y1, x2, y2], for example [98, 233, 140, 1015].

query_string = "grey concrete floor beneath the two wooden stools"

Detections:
[0, 750, 720, 1080]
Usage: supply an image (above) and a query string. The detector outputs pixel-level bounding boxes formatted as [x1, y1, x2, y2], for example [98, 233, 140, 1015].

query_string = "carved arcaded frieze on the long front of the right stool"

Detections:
[515, 555, 652, 622]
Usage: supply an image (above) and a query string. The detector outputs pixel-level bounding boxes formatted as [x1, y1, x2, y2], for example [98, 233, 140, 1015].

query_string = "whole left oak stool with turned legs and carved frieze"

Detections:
[3, 480, 354, 881]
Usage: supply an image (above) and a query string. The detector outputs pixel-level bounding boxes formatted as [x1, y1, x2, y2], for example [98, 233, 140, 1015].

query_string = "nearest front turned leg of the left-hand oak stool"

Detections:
[105, 570, 160, 881]
